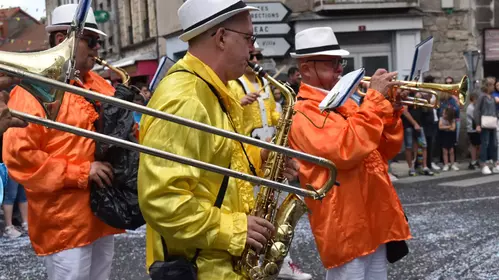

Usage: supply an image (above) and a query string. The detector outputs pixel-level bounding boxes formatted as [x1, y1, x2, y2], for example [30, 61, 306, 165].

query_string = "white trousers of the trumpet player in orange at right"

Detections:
[326, 244, 388, 280]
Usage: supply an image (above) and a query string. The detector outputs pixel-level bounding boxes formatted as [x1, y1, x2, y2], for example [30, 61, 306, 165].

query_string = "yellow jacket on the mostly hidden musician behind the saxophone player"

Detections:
[229, 75, 280, 140]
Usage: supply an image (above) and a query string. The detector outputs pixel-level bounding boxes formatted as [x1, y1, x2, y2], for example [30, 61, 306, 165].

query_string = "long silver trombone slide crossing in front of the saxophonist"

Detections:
[0, 63, 336, 200]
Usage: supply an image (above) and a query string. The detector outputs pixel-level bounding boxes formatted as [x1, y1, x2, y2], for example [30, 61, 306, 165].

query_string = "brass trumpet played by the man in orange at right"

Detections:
[359, 76, 468, 109]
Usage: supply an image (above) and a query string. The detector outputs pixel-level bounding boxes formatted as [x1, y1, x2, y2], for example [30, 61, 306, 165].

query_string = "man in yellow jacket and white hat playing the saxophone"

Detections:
[138, 0, 297, 280]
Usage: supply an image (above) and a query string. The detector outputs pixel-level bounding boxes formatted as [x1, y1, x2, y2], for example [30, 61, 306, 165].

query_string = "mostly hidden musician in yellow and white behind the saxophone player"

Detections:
[229, 42, 280, 140]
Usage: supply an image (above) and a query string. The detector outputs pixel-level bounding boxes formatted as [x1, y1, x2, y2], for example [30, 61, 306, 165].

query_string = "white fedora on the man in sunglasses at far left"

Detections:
[45, 4, 107, 36]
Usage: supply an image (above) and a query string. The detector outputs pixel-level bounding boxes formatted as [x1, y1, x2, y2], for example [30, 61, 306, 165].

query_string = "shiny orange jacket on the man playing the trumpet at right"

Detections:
[289, 83, 411, 269]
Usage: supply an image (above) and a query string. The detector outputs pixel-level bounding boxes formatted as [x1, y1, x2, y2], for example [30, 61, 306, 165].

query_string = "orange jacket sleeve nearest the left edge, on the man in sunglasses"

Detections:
[3, 87, 90, 192]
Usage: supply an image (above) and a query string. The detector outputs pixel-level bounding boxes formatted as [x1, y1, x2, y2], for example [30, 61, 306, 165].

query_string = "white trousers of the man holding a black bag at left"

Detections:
[43, 235, 114, 280]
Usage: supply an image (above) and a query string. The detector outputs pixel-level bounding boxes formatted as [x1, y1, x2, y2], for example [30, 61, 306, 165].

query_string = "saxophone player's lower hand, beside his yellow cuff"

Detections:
[246, 216, 275, 252]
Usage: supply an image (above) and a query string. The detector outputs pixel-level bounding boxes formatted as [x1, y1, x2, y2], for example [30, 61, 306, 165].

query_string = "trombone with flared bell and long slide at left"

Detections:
[0, 44, 336, 199]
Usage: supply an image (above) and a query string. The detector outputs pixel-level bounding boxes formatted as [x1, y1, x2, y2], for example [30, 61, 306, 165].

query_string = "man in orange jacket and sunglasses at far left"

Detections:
[3, 4, 124, 280]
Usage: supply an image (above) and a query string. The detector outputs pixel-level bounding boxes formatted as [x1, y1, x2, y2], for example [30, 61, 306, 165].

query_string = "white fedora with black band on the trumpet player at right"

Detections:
[291, 27, 350, 58]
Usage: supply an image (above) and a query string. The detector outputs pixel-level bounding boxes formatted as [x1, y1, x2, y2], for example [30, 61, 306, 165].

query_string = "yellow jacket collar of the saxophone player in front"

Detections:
[168, 52, 243, 111]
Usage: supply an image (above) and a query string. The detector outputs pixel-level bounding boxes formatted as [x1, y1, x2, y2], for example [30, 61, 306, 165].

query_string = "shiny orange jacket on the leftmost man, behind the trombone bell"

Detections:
[3, 72, 124, 256]
